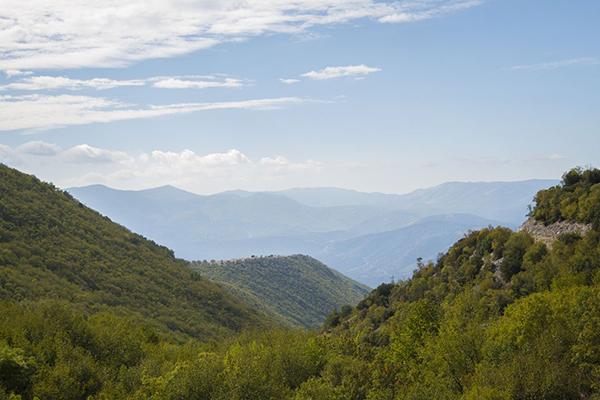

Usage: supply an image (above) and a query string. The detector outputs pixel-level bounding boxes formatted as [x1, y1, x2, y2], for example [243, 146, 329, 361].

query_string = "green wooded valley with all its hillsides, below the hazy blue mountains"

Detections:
[0, 166, 600, 400]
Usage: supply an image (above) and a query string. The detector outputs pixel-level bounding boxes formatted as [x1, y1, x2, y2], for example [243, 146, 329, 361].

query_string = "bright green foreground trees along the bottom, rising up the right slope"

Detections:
[0, 167, 600, 400]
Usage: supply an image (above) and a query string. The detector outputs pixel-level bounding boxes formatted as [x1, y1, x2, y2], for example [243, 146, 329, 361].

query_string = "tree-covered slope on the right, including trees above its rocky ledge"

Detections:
[297, 170, 600, 400]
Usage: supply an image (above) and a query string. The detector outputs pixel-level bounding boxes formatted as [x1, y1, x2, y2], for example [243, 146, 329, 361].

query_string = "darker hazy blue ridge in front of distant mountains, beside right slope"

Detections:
[322, 214, 500, 286]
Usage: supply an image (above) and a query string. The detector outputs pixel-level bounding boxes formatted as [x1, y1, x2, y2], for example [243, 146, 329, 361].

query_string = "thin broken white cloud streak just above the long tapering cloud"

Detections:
[0, 75, 248, 91]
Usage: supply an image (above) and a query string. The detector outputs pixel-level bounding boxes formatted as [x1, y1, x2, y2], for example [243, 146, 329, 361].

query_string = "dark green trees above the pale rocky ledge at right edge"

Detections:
[531, 168, 600, 229]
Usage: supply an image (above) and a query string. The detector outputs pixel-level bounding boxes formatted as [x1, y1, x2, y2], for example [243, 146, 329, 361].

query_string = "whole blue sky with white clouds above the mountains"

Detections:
[0, 0, 600, 193]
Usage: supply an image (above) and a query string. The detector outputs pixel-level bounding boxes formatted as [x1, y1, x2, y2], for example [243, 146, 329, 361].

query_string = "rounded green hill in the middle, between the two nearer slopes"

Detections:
[191, 255, 370, 328]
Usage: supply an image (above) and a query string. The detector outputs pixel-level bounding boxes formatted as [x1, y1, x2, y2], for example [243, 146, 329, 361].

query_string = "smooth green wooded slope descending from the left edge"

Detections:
[0, 165, 266, 339]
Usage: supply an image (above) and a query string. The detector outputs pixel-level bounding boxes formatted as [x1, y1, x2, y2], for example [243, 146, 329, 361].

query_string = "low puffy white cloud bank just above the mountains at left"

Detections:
[0, 141, 323, 193]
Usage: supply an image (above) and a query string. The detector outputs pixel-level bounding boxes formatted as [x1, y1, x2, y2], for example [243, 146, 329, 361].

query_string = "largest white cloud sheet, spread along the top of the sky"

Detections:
[0, 0, 479, 70]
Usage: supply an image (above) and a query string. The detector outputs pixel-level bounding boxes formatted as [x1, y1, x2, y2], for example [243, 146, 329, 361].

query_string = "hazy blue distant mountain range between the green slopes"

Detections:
[68, 180, 558, 286]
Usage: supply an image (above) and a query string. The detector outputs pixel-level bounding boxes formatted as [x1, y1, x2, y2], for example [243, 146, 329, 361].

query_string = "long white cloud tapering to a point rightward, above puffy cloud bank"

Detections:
[0, 94, 305, 131]
